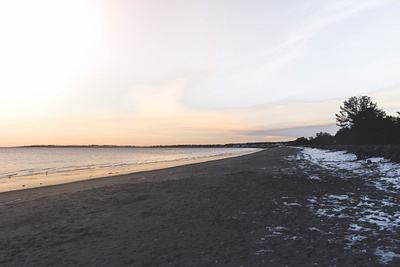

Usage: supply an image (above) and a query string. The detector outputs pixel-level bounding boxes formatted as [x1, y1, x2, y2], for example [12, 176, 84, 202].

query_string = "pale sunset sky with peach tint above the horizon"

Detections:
[0, 0, 400, 146]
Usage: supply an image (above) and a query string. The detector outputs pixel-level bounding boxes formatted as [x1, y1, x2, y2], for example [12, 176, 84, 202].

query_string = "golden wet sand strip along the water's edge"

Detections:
[0, 150, 262, 193]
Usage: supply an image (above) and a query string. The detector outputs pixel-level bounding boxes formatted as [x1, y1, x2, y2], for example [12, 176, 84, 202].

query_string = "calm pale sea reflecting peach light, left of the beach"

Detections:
[0, 147, 259, 178]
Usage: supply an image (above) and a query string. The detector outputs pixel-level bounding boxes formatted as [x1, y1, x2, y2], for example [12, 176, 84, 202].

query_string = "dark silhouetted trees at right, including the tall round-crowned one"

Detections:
[289, 96, 400, 161]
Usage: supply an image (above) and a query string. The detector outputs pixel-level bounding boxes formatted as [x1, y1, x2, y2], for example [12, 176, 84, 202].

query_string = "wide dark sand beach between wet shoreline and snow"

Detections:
[0, 148, 399, 267]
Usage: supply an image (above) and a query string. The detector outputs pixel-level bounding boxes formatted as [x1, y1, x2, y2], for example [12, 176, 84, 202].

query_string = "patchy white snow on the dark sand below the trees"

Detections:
[286, 148, 400, 264]
